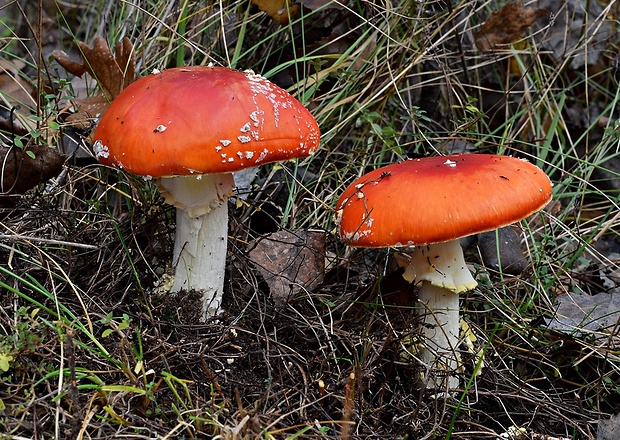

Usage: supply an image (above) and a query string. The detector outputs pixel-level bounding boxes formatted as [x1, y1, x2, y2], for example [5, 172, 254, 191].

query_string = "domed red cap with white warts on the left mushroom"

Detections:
[94, 66, 320, 177]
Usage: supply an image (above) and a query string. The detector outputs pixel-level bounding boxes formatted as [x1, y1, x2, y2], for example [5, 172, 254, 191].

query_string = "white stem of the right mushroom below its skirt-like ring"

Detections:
[418, 281, 459, 390]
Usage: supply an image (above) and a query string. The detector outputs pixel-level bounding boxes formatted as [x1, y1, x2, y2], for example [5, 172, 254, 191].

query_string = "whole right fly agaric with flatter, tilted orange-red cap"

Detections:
[336, 154, 552, 389]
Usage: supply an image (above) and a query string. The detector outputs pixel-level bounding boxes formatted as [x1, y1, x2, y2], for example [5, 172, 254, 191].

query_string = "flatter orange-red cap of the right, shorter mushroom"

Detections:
[336, 154, 552, 247]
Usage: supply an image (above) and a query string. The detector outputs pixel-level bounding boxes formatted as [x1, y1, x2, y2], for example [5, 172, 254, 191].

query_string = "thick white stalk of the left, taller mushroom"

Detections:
[158, 173, 234, 321]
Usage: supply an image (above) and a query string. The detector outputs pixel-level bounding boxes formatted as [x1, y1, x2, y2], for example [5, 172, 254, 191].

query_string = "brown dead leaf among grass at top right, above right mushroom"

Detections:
[474, 2, 549, 53]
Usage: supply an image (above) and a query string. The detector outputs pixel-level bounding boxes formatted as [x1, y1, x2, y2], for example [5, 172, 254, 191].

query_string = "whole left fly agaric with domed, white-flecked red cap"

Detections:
[93, 66, 320, 320]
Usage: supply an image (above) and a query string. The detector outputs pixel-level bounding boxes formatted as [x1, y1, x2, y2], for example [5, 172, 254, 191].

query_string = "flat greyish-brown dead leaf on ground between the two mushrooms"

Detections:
[249, 231, 325, 307]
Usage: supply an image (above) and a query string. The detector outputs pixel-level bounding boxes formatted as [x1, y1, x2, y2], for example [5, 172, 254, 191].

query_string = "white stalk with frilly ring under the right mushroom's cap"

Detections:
[403, 240, 477, 390]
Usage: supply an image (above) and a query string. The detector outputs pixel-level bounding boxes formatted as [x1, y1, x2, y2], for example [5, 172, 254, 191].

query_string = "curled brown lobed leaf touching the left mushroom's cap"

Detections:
[53, 37, 136, 128]
